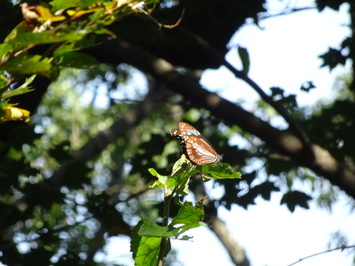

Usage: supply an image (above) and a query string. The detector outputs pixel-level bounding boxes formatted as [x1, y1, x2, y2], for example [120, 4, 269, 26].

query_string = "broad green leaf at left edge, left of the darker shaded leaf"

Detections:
[0, 55, 58, 79]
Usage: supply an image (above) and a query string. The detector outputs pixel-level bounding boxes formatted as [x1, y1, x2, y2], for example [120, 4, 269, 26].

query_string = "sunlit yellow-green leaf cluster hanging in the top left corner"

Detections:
[0, 0, 154, 121]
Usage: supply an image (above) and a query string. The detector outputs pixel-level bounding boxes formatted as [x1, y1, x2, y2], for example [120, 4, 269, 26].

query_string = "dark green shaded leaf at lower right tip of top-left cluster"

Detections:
[56, 52, 98, 69]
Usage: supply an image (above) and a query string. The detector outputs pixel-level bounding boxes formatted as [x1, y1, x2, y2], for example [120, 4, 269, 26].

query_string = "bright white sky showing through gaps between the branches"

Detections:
[96, 0, 355, 266]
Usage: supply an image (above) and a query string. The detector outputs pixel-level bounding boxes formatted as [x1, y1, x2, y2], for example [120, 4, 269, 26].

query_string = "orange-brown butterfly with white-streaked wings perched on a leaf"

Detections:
[170, 122, 223, 165]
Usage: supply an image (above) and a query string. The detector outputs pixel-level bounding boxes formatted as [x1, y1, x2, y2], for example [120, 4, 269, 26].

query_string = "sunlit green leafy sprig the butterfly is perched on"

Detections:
[131, 155, 241, 265]
